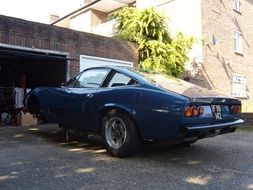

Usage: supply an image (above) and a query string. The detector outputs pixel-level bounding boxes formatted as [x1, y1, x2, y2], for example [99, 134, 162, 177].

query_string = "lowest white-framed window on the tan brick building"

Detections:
[232, 74, 247, 98]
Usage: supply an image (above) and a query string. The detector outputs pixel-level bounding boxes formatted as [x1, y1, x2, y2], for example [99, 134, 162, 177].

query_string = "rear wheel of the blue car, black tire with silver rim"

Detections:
[102, 110, 142, 158]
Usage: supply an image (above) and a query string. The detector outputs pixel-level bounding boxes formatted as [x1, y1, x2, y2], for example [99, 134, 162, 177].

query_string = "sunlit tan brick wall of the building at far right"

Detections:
[201, 0, 253, 105]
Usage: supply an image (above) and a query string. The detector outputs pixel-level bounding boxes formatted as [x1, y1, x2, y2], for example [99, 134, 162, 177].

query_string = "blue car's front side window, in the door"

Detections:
[75, 69, 108, 88]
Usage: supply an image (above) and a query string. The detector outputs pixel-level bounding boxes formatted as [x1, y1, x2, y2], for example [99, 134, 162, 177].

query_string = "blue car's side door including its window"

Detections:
[60, 68, 109, 128]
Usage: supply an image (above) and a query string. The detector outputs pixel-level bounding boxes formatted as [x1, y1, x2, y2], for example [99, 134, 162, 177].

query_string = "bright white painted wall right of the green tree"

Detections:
[136, 0, 202, 62]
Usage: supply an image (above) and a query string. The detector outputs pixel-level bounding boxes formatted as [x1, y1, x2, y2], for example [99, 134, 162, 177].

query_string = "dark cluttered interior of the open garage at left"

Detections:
[0, 47, 67, 126]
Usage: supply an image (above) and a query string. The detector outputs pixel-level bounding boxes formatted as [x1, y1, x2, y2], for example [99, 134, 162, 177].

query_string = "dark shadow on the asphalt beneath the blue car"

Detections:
[23, 125, 223, 162]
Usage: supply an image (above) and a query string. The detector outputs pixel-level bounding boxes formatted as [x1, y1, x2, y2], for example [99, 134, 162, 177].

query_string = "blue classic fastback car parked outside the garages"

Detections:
[25, 66, 244, 157]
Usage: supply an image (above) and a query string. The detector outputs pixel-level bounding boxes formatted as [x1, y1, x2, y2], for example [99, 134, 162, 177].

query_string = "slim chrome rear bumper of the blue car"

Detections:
[185, 119, 244, 131]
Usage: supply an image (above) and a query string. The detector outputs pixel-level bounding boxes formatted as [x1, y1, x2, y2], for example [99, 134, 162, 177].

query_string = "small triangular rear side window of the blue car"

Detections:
[108, 72, 137, 87]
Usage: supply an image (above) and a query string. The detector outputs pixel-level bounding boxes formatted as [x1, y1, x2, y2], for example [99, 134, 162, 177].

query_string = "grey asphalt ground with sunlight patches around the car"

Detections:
[0, 126, 253, 190]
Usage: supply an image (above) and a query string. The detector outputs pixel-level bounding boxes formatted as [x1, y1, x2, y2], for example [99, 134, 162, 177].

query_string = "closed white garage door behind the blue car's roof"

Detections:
[80, 55, 133, 71]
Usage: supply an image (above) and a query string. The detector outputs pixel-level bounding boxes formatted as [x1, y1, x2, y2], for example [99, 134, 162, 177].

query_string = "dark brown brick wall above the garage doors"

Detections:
[0, 15, 137, 76]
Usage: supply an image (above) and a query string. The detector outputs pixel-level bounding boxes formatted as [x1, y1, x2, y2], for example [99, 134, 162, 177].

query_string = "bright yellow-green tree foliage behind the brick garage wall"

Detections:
[112, 7, 194, 77]
